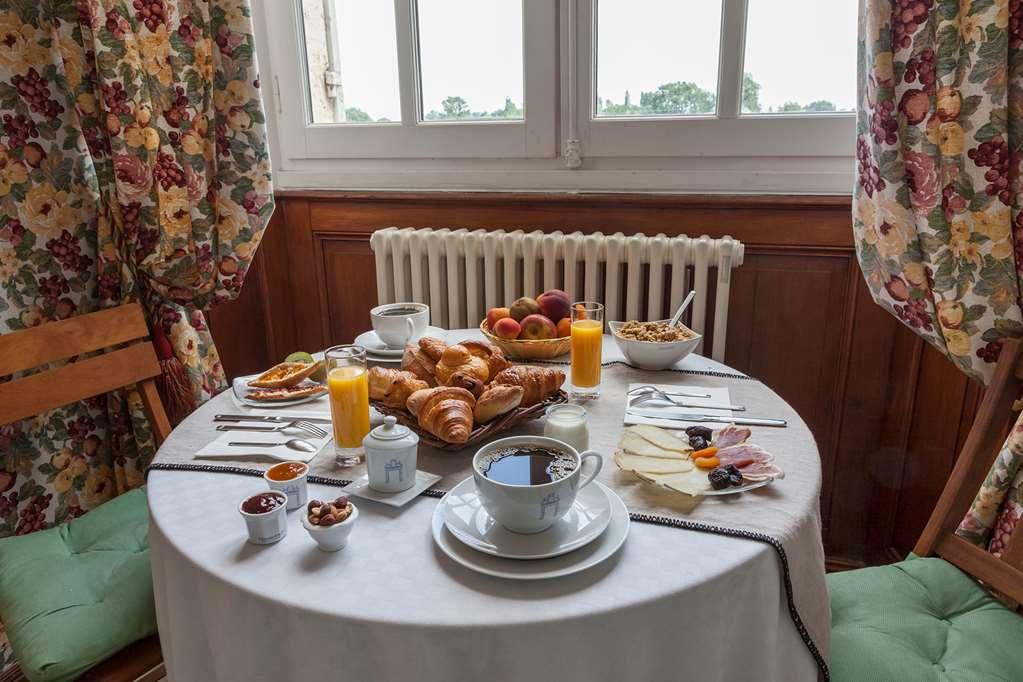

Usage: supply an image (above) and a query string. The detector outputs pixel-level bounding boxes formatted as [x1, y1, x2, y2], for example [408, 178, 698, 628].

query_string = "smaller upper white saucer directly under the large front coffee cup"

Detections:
[441, 476, 611, 559]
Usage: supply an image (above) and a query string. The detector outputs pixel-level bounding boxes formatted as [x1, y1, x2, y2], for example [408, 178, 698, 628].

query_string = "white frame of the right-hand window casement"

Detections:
[567, 0, 856, 157]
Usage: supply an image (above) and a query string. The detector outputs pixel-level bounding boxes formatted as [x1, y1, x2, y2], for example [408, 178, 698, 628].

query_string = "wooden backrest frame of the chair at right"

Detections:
[914, 339, 1023, 602]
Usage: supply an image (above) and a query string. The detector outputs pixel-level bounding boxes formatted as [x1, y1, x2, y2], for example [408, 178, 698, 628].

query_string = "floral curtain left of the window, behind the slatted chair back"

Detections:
[0, 0, 273, 666]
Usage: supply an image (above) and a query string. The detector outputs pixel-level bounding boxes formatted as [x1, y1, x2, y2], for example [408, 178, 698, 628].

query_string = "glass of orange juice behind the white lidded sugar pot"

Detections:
[323, 346, 369, 466]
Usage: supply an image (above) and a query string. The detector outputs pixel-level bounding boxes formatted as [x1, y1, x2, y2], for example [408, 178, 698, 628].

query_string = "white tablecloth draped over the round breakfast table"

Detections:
[148, 332, 819, 682]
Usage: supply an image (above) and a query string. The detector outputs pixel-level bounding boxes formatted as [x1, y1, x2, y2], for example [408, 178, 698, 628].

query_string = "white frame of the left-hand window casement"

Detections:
[262, 0, 558, 161]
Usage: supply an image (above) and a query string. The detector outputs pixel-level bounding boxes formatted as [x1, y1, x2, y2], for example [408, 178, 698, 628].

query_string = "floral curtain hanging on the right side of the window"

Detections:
[853, 0, 1023, 551]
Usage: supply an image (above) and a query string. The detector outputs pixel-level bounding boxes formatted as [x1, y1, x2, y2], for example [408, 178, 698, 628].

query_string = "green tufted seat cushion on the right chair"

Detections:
[828, 557, 1023, 682]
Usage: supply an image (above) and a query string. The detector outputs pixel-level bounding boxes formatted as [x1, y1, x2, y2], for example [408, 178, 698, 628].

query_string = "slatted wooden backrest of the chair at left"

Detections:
[0, 304, 171, 444]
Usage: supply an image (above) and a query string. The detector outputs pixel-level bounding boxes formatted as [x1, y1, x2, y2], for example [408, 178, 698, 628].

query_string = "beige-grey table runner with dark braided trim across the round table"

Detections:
[150, 362, 831, 679]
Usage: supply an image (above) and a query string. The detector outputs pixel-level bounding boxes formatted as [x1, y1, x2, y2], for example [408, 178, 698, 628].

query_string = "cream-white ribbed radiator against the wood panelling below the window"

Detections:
[369, 227, 744, 361]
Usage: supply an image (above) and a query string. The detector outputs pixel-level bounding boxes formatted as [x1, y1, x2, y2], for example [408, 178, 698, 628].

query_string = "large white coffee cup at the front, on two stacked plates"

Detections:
[473, 436, 604, 533]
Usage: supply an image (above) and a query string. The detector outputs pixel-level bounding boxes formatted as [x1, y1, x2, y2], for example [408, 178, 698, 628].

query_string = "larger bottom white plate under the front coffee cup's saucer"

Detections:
[432, 482, 630, 580]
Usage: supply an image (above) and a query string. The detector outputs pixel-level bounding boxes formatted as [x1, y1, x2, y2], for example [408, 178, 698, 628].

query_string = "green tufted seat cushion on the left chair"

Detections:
[0, 489, 157, 682]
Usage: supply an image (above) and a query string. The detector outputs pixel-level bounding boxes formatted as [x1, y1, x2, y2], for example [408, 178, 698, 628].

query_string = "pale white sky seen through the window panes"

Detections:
[317, 0, 857, 121]
